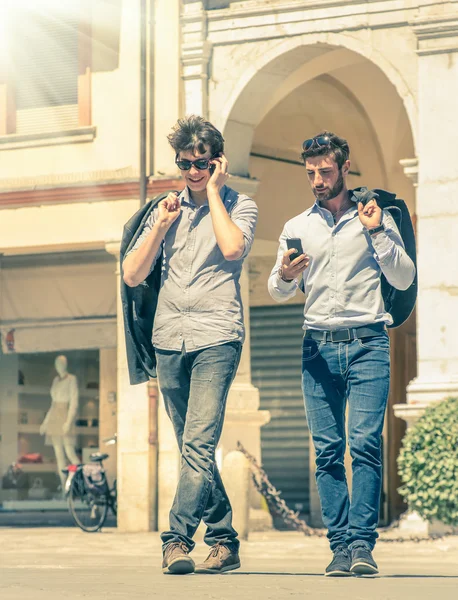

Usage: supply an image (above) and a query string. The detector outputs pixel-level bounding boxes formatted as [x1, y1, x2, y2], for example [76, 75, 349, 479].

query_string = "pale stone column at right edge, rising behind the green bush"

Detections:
[395, 12, 458, 533]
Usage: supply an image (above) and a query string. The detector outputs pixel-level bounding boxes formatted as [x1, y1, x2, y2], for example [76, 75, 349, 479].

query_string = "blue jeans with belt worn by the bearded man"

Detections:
[302, 332, 390, 550]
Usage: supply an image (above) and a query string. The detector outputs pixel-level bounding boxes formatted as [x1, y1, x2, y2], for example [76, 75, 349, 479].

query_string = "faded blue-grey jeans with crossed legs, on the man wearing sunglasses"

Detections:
[156, 342, 242, 550]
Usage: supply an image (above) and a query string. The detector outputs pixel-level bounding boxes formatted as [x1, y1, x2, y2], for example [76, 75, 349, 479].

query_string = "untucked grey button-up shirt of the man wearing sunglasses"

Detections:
[129, 186, 258, 352]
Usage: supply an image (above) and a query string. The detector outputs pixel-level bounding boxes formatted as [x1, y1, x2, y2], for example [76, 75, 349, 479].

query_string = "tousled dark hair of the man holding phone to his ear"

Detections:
[167, 115, 224, 156]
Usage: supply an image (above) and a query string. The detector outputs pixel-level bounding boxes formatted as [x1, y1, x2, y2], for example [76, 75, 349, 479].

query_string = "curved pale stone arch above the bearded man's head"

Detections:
[214, 33, 417, 176]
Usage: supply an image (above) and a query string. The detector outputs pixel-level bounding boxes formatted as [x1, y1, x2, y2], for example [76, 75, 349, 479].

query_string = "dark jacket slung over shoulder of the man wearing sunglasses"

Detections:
[120, 192, 174, 385]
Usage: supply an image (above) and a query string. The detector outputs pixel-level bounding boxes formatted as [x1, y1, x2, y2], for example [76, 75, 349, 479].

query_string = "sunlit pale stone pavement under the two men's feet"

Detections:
[0, 527, 458, 600]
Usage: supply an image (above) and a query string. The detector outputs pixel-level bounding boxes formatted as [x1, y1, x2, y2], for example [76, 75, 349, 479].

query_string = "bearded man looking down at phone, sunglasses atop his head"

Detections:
[268, 131, 415, 576]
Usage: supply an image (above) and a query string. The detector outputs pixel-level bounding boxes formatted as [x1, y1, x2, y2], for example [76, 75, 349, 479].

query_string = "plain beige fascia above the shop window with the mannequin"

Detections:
[0, 252, 116, 353]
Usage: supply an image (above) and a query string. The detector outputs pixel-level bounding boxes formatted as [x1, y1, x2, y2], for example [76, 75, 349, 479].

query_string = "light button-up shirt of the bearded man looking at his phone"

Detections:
[268, 202, 415, 330]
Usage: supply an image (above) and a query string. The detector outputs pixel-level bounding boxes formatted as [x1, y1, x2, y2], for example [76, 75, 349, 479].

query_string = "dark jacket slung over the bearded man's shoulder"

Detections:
[350, 187, 418, 327]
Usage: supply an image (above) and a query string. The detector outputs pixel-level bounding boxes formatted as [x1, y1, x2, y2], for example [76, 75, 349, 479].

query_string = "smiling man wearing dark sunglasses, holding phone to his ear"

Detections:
[123, 116, 258, 574]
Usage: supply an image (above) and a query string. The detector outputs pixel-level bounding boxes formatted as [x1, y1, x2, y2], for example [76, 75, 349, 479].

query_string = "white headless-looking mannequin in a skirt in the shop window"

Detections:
[40, 355, 80, 489]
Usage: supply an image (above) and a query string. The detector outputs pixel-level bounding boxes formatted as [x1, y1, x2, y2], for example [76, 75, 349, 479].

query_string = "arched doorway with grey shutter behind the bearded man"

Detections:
[223, 35, 416, 522]
